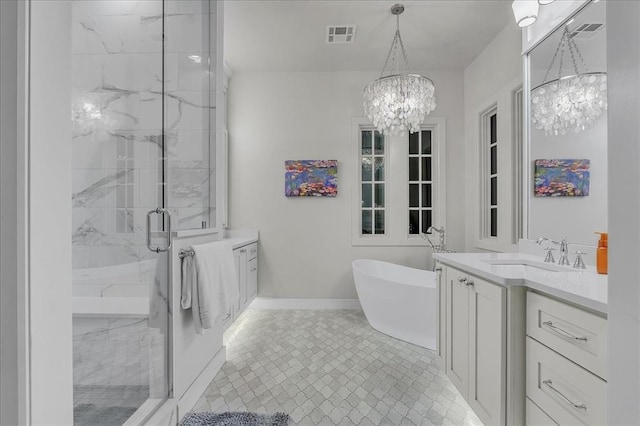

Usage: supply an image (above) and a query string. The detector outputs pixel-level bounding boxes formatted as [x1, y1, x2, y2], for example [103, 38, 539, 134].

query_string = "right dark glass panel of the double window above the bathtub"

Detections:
[408, 130, 433, 235]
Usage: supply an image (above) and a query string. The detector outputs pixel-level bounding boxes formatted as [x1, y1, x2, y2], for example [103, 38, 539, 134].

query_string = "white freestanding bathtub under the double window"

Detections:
[352, 259, 438, 349]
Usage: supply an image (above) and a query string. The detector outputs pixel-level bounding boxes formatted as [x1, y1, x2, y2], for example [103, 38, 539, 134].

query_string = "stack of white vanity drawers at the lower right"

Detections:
[526, 292, 607, 425]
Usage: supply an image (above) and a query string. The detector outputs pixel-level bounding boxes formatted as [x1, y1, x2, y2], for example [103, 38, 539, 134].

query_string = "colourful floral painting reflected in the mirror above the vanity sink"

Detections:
[534, 160, 589, 197]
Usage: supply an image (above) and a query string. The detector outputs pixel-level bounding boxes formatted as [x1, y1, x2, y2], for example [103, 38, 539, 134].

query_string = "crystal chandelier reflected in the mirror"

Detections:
[531, 26, 607, 135]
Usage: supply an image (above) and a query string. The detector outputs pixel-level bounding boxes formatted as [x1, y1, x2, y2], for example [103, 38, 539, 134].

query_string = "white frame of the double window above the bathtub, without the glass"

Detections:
[351, 117, 447, 246]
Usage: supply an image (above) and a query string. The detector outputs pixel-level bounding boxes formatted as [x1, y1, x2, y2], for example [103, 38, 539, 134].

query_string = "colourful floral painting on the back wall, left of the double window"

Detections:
[284, 160, 338, 197]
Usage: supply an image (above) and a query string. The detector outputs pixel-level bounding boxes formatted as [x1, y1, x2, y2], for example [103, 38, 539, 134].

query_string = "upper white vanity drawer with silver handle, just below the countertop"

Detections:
[527, 292, 607, 380]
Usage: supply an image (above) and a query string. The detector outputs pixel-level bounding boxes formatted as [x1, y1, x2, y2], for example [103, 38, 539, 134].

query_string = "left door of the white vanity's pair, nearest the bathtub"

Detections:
[445, 268, 469, 398]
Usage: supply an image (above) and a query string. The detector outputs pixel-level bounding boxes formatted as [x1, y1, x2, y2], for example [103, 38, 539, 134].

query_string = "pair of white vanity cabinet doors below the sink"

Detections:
[441, 266, 507, 425]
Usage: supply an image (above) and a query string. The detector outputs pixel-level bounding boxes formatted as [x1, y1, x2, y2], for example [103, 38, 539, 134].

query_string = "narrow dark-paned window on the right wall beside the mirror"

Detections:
[480, 106, 498, 238]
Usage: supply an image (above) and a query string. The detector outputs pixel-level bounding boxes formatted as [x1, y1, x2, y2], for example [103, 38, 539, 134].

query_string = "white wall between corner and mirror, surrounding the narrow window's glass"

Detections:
[464, 22, 522, 251]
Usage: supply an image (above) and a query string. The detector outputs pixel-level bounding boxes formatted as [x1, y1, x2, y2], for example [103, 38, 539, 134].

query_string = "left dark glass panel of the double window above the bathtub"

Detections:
[360, 129, 386, 235]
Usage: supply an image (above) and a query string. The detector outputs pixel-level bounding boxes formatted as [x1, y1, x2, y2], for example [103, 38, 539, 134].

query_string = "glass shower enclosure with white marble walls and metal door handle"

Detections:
[70, 0, 216, 425]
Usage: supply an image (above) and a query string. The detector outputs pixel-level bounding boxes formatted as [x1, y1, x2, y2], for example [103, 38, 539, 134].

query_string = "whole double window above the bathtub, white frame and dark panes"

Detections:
[351, 117, 446, 246]
